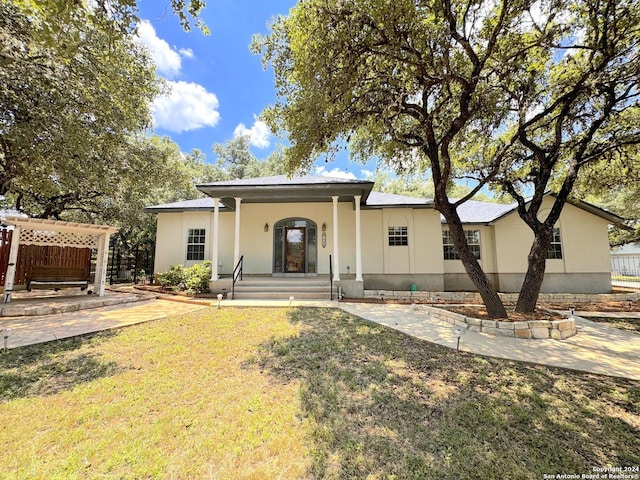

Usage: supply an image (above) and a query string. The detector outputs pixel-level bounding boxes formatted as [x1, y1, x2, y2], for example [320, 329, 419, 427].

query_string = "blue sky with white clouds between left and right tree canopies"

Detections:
[138, 0, 375, 178]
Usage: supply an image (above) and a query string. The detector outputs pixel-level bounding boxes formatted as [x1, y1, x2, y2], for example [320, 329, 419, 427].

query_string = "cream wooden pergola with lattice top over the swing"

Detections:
[3, 216, 118, 303]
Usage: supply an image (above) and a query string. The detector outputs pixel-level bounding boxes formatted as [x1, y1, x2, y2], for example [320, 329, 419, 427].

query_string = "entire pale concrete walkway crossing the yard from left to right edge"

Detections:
[0, 298, 640, 380]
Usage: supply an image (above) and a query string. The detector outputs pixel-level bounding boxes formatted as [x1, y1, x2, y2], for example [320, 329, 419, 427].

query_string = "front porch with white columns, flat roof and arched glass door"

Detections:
[199, 177, 373, 282]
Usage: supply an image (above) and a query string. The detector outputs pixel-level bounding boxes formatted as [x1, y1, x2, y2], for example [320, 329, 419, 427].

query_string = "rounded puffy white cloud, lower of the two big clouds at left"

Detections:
[152, 81, 220, 133]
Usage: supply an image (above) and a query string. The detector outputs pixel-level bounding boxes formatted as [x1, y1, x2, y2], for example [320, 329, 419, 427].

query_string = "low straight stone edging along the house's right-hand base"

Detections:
[364, 290, 640, 304]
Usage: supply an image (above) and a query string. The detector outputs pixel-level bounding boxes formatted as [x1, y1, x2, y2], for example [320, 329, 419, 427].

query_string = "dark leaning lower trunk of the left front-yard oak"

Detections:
[441, 202, 507, 318]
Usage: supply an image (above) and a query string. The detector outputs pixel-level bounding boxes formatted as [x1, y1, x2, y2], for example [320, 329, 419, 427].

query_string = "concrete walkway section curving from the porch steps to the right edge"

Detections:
[340, 303, 640, 380]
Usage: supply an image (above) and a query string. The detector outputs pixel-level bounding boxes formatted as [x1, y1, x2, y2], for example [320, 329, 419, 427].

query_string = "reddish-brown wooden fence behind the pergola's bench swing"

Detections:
[0, 228, 91, 286]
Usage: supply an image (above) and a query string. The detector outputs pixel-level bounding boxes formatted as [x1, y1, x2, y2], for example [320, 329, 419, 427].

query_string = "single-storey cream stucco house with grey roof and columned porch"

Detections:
[147, 176, 622, 296]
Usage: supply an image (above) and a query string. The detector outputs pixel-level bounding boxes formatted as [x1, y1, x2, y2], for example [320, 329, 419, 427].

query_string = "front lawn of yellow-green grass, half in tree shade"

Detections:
[0, 308, 640, 479]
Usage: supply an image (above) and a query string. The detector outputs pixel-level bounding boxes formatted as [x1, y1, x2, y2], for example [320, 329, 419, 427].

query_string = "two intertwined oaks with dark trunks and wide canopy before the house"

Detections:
[253, 0, 640, 317]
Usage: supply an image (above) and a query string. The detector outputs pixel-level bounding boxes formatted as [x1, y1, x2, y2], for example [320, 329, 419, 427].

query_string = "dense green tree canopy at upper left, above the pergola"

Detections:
[0, 4, 162, 212]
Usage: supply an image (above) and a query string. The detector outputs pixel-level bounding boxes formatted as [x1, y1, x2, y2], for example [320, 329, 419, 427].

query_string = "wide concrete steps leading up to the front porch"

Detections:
[234, 276, 336, 300]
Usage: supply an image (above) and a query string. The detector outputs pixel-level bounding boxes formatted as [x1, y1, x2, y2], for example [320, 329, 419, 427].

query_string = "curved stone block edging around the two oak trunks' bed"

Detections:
[420, 305, 578, 340]
